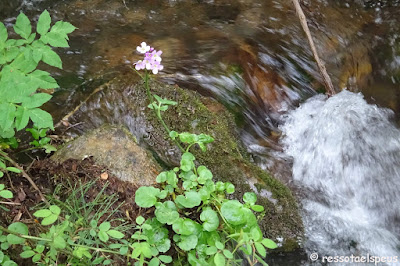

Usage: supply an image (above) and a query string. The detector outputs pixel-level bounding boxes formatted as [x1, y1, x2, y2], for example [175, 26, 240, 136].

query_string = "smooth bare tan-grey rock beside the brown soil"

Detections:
[52, 125, 161, 186]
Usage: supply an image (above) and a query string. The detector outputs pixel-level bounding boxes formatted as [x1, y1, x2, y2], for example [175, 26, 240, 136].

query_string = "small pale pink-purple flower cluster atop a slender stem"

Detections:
[135, 42, 164, 74]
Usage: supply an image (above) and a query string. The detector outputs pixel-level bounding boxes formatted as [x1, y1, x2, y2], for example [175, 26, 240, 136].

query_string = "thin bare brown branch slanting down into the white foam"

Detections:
[293, 0, 336, 96]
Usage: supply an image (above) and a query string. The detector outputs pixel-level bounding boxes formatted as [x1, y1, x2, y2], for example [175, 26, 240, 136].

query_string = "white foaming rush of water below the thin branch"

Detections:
[281, 91, 400, 265]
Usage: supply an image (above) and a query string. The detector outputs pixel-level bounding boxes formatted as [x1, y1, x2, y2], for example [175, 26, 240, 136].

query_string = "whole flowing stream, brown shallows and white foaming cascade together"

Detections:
[0, 0, 400, 266]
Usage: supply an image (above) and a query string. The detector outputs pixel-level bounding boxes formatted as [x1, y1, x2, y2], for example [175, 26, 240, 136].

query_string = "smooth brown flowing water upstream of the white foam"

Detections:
[0, 0, 400, 265]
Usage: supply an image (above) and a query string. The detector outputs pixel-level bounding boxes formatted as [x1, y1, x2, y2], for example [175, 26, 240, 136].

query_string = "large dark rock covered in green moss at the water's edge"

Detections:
[56, 71, 303, 250]
